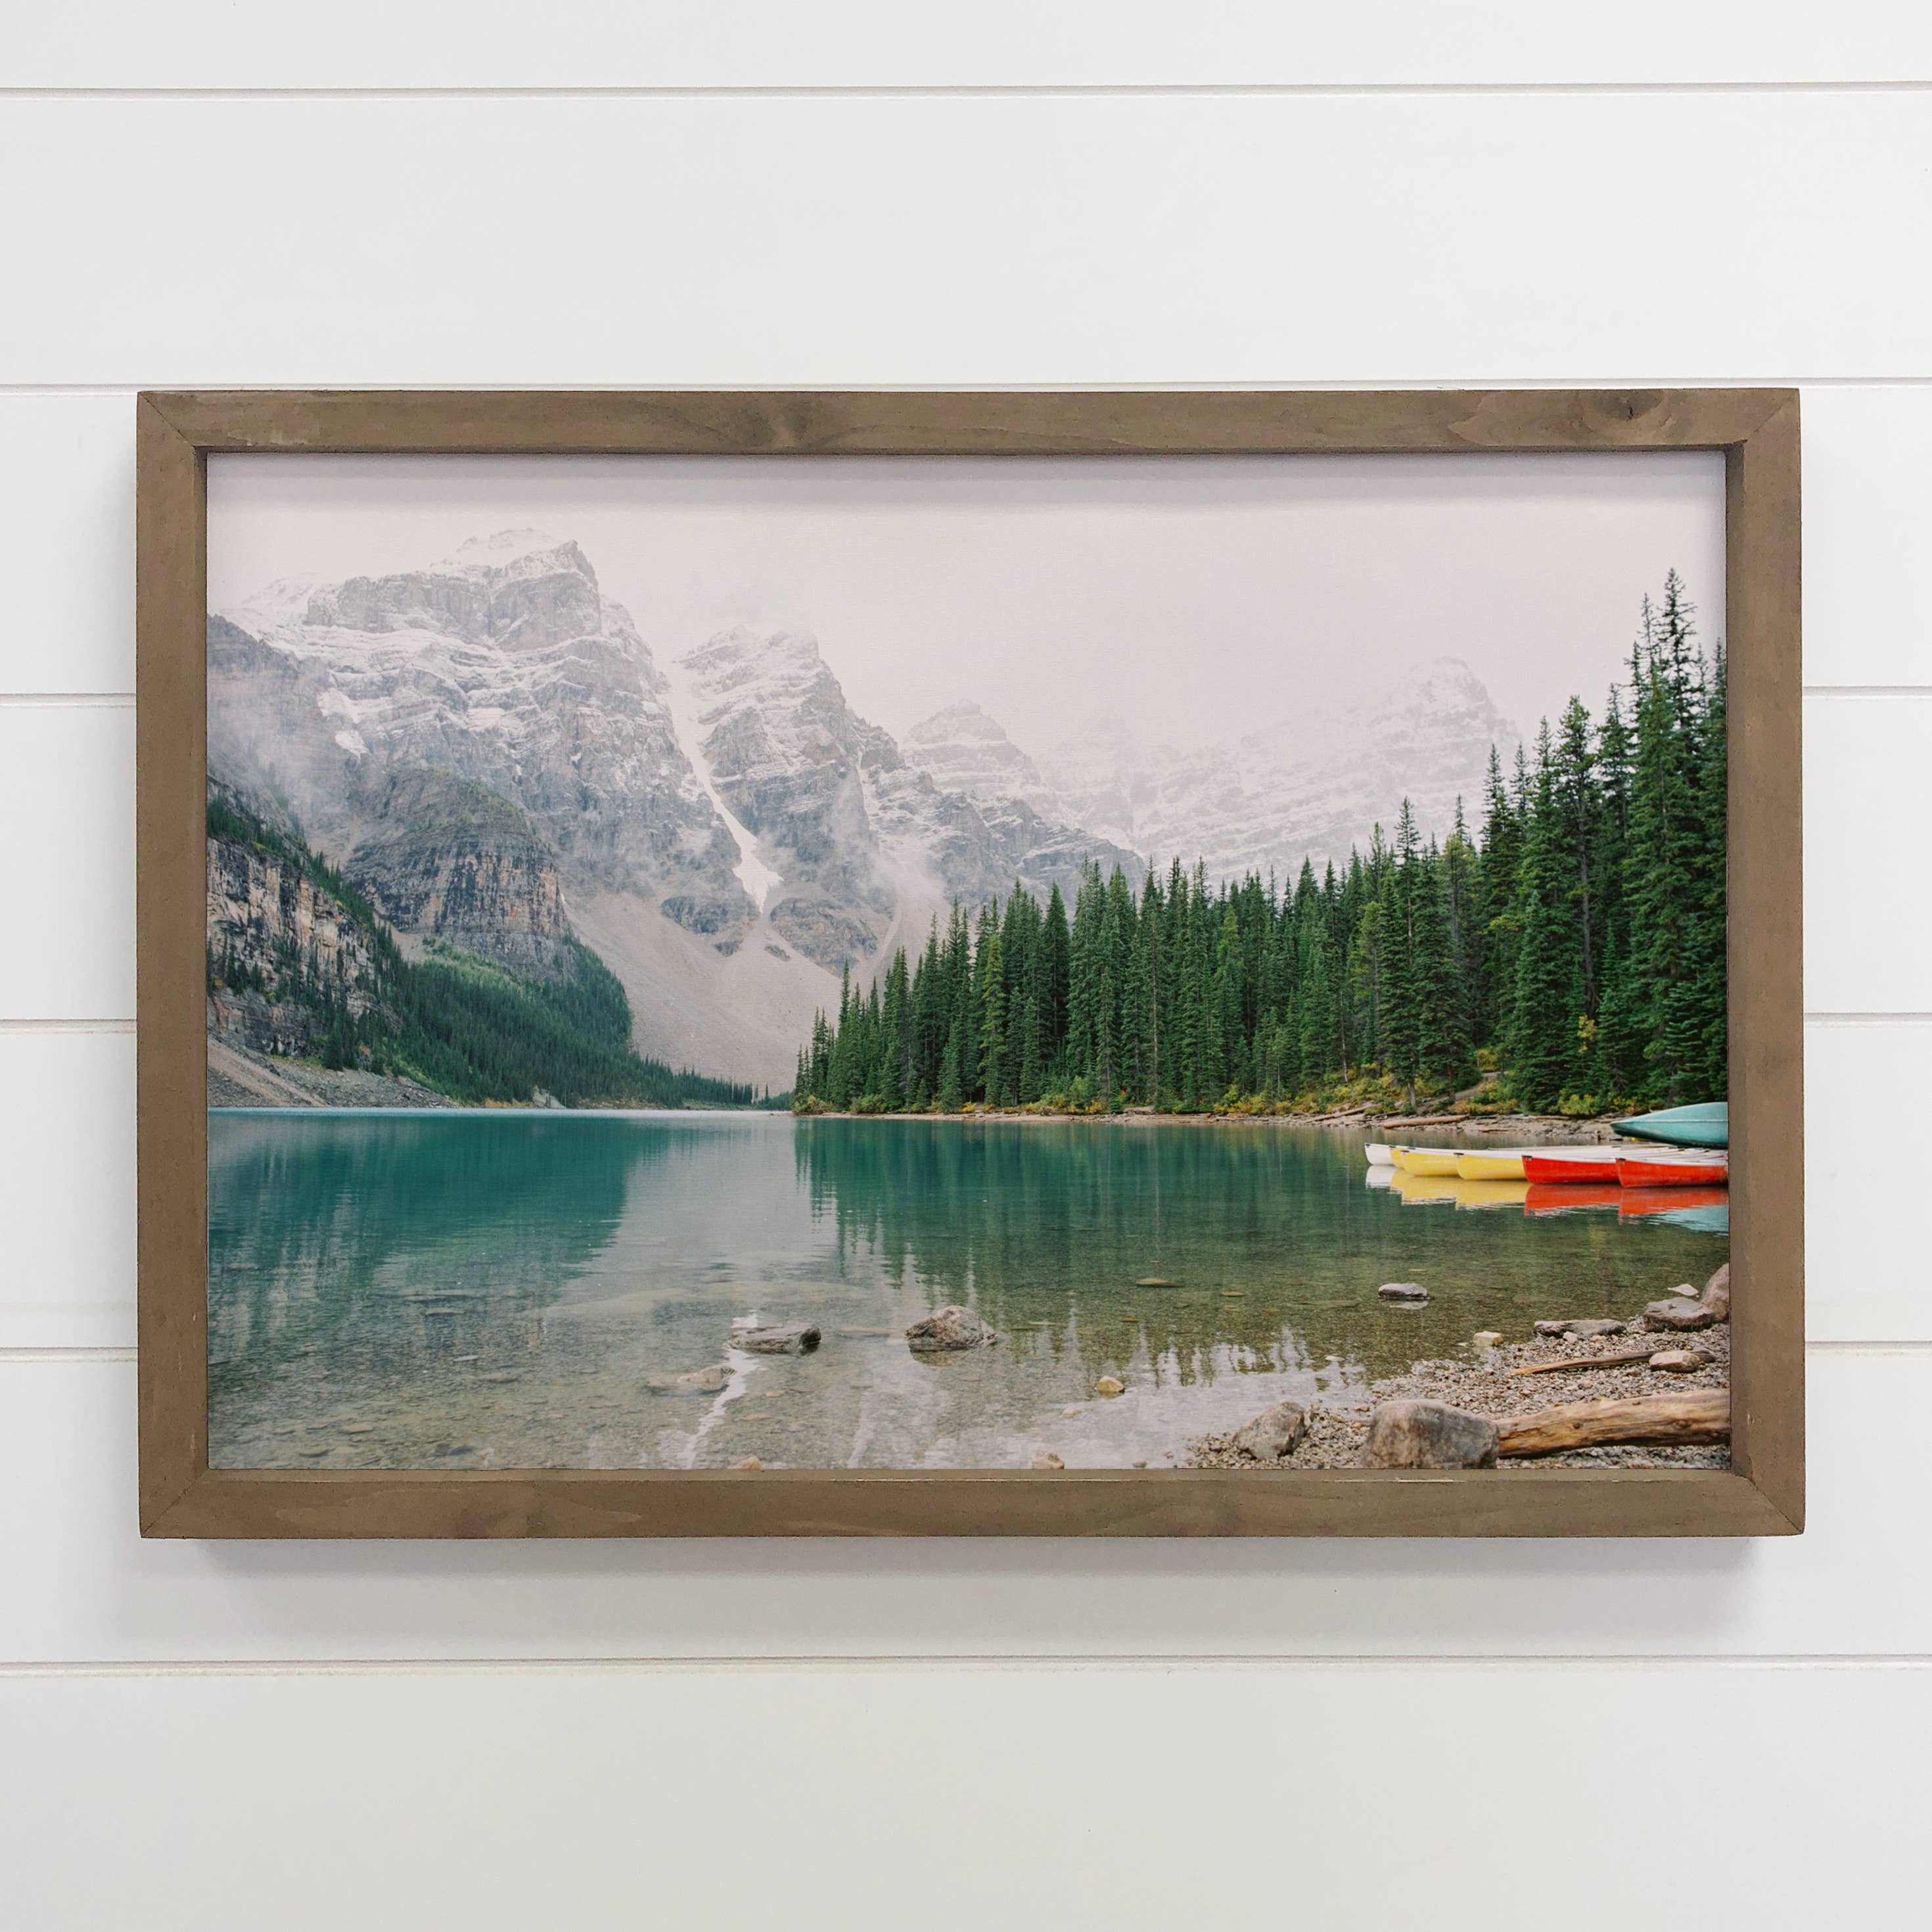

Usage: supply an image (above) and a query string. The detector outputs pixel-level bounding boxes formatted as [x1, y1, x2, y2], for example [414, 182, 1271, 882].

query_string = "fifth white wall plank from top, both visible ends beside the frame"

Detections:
[0, 1020, 1900, 1348]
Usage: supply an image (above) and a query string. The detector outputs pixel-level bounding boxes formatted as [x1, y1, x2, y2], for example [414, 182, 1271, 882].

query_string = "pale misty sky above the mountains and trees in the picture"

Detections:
[209, 452, 1723, 754]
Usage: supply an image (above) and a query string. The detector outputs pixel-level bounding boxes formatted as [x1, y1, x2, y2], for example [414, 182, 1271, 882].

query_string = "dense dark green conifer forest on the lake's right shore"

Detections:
[792, 572, 1727, 1115]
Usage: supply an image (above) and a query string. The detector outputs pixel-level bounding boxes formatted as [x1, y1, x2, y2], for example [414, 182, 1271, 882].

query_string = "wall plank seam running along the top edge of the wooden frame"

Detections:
[0, 371, 1932, 398]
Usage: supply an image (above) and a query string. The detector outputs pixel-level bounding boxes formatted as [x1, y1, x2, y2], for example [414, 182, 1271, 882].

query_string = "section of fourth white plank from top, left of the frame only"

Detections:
[0, 705, 133, 1020]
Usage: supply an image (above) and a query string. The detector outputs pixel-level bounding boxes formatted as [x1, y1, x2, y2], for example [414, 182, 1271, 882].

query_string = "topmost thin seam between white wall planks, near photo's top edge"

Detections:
[0, 78, 1932, 103]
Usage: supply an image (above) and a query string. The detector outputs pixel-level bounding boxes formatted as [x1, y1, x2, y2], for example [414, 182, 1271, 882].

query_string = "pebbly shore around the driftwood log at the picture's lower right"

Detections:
[1175, 1318, 1731, 1470]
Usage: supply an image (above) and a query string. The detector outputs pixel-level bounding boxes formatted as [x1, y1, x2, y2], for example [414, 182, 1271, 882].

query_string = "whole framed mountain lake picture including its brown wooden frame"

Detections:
[137, 390, 1805, 1538]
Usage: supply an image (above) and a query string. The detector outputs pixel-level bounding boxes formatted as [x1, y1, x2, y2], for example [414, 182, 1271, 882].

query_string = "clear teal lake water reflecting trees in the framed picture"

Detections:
[209, 1109, 1729, 1468]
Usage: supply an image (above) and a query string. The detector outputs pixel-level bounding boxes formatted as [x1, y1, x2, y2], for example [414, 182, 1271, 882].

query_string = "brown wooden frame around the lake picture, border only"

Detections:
[137, 388, 1805, 1538]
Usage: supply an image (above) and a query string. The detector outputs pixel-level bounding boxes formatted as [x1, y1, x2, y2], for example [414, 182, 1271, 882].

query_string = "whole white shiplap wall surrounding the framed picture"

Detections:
[0, 18, 1932, 1932]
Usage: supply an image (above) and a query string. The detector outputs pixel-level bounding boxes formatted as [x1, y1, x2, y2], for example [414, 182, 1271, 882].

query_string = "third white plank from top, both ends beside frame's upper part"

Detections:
[0, 382, 1932, 693]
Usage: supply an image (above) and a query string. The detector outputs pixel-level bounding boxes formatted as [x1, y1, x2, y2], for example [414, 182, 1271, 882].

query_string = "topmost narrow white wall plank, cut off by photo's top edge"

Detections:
[8, 0, 1932, 89]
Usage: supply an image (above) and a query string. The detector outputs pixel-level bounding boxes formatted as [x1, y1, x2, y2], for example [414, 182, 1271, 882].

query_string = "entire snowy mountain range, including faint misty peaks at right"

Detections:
[209, 530, 1515, 1088]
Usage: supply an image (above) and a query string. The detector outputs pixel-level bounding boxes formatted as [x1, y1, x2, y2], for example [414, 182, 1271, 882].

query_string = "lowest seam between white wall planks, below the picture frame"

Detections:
[0, 1650, 1932, 1681]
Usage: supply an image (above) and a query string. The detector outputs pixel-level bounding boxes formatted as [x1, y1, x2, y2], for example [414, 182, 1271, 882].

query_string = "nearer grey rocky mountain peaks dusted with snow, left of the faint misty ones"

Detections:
[209, 532, 1134, 1086]
